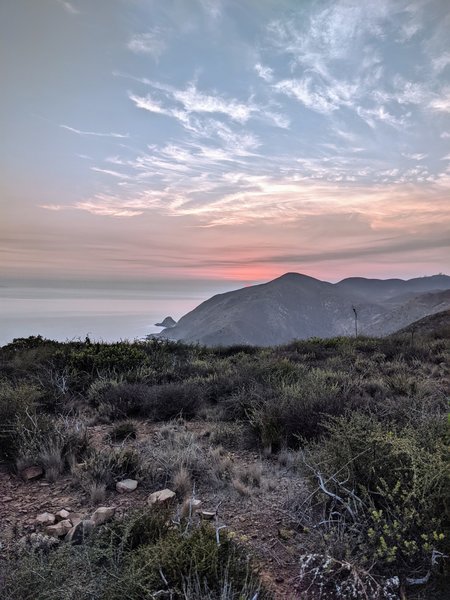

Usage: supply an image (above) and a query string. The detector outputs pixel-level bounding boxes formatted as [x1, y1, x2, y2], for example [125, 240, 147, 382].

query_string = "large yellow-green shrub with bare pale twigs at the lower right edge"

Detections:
[298, 414, 449, 577]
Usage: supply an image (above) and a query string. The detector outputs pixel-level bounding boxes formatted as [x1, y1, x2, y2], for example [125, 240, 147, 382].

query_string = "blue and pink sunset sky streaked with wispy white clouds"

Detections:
[0, 0, 450, 290]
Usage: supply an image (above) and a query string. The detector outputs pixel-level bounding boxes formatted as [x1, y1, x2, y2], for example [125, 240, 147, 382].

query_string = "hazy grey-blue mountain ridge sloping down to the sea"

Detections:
[159, 273, 450, 346]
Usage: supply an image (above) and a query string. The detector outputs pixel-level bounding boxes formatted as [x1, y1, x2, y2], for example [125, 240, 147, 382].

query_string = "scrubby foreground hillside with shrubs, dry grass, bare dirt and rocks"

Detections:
[0, 335, 450, 600]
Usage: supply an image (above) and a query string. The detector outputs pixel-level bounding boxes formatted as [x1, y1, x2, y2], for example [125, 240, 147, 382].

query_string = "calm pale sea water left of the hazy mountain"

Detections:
[0, 286, 208, 345]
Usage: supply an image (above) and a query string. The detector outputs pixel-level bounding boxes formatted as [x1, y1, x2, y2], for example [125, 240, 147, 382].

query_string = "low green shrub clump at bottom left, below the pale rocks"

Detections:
[0, 509, 270, 600]
